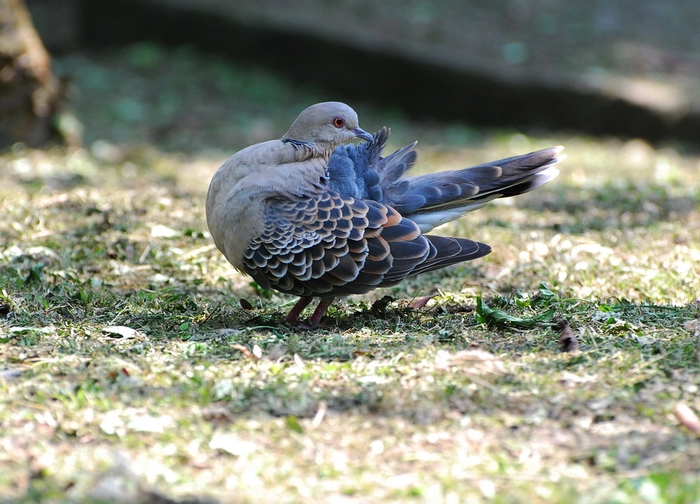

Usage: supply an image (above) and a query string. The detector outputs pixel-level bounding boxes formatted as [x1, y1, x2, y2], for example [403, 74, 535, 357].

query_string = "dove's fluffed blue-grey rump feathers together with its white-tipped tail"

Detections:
[328, 128, 564, 232]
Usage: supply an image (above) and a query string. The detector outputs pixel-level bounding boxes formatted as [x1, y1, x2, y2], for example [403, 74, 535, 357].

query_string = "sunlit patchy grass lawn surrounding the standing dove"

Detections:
[0, 46, 700, 503]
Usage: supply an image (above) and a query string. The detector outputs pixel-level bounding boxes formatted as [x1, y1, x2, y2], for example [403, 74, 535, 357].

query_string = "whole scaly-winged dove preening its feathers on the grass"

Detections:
[205, 102, 565, 327]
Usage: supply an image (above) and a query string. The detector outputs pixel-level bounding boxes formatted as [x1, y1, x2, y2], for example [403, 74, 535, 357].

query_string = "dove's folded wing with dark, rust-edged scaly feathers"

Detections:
[244, 191, 490, 297]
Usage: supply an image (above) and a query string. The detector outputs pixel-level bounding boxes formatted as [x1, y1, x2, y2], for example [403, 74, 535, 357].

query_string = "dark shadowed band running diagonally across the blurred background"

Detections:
[34, 0, 700, 144]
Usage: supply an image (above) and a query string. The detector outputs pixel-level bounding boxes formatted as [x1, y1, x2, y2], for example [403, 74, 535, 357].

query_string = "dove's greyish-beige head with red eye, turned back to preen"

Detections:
[282, 102, 373, 153]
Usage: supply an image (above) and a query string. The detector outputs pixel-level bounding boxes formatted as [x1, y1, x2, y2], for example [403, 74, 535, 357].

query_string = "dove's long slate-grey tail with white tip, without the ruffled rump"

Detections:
[384, 147, 565, 232]
